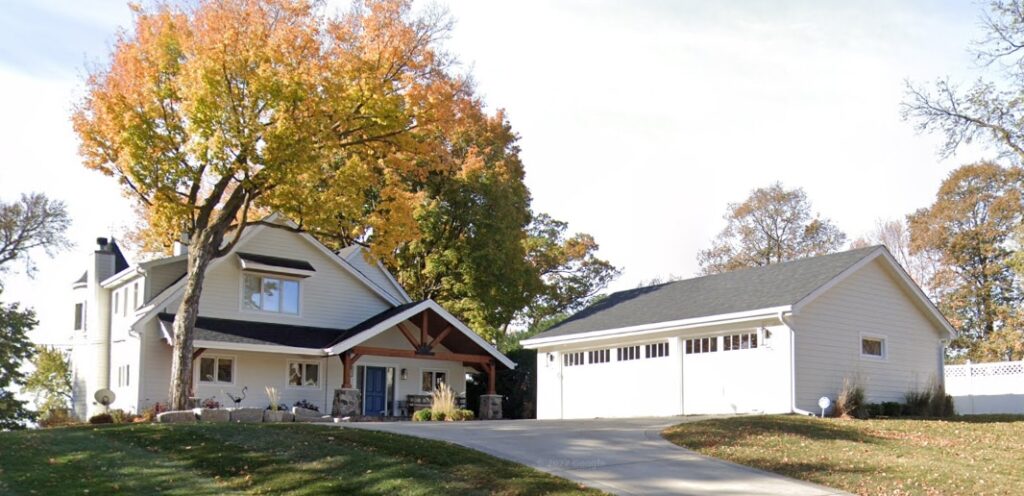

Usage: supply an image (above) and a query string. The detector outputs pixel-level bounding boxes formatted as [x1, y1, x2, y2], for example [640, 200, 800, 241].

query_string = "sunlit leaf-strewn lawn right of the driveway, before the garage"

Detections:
[663, 415, 1024, 495]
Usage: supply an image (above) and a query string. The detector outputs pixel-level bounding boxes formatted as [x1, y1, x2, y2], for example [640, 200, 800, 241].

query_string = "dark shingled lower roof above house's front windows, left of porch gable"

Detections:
[158, 313, 352, 348]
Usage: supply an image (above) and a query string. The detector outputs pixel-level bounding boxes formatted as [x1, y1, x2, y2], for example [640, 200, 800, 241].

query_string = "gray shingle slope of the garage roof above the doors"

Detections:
[534, 246, 879, 339]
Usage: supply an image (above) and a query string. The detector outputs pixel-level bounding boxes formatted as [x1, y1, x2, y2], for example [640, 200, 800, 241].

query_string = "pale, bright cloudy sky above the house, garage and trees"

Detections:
[0, 0, 991, 343]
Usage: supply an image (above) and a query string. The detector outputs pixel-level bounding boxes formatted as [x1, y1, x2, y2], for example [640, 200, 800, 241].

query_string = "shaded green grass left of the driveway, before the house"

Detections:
[0, 423, 597, 496]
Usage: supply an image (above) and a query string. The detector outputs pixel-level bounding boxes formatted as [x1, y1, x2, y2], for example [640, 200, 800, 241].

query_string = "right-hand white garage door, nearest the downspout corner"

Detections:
[683, 332, 768, 415]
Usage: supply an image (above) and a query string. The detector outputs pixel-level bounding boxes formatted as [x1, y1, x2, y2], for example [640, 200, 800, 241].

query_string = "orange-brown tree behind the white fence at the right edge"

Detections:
[909, 163, 1024, 360]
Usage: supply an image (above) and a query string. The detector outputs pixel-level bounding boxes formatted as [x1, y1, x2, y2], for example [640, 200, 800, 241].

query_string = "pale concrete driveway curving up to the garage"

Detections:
[341, 417, 847, 496]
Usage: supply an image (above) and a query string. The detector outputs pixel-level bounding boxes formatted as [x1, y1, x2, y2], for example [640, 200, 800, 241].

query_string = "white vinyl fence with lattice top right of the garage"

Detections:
[945, 361, 1024, 415]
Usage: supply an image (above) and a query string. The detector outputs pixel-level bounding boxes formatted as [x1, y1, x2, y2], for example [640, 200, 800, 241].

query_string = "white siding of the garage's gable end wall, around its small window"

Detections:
[792, 259, 944, 411]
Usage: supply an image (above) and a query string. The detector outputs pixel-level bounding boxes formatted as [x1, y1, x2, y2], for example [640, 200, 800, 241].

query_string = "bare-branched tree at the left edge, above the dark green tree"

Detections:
[0, 193, 71, 276]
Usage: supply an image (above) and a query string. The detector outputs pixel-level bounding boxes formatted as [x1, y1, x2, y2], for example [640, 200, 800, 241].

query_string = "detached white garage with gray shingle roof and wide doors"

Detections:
[522, 246, 954, 418]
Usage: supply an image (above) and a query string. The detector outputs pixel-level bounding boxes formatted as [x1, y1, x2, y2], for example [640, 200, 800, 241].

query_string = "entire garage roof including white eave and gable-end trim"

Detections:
[523, 246, 954, 346]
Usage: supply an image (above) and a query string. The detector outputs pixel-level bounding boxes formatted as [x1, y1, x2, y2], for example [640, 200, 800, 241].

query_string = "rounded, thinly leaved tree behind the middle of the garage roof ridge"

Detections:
[697, 182, 846, 275]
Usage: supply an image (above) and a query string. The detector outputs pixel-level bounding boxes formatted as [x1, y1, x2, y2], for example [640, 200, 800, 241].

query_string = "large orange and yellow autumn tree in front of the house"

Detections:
[73, 0, 479, 409]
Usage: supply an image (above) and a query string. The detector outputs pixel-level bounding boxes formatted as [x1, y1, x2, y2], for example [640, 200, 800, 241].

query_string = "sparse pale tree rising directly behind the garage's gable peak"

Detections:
[850, 219, 940, 294]
